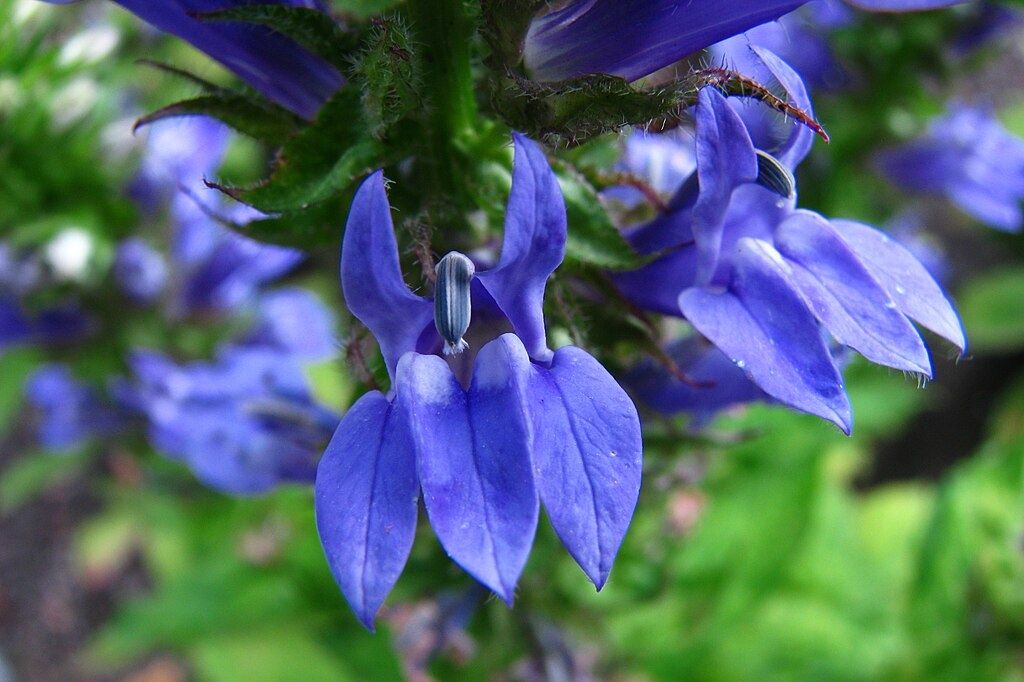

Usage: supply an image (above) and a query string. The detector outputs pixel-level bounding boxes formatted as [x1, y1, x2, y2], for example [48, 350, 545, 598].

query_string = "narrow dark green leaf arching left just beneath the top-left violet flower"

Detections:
[135, 88, 302, 146]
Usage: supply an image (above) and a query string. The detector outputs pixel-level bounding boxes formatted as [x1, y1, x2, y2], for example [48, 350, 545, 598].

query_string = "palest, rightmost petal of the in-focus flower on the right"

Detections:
[831, 220, 967, 352]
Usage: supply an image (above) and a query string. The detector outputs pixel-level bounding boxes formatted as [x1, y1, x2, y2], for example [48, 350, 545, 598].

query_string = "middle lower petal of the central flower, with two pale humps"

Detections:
[395, 334, 540, 604]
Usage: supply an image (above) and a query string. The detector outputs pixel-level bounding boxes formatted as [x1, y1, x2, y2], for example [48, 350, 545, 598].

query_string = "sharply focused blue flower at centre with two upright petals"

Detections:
[315, 135, 642, 628]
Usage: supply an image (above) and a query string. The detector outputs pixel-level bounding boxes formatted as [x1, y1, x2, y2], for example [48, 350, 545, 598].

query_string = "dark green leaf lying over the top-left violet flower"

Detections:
[197, 4, 358, 71]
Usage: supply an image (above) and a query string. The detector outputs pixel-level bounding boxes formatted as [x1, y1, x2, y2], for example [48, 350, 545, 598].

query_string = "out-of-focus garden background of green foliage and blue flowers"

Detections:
[0, 0, 1024, 682]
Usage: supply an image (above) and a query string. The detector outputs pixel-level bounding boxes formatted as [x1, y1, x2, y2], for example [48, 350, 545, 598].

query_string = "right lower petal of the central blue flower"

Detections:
[530, 346, 643, 590]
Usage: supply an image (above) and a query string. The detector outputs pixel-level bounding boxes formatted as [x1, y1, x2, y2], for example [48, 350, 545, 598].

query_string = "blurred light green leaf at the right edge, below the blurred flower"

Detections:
[958, 268, 1024, 352]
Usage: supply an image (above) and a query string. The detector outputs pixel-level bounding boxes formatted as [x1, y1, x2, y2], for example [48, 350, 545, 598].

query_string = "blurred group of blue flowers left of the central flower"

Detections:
[11, 111, 340, 495]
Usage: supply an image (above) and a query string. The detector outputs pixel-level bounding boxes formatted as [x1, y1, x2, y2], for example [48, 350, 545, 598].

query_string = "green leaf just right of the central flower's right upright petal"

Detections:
[558, 169, 644, 270]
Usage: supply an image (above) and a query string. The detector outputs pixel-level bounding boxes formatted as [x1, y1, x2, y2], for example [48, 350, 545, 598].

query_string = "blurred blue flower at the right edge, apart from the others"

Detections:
[879, 104, 1024, 231]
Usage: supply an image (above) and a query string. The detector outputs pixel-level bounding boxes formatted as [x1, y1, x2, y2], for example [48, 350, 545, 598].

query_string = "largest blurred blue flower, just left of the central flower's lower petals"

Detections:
[121, 346, 338, 495]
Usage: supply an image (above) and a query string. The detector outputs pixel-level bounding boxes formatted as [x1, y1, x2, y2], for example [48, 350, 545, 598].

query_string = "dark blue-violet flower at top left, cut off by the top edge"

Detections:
[40, 0, 344, 118]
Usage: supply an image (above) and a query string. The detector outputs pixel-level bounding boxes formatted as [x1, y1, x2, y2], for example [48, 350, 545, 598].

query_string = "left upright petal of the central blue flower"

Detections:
[341, 171, 434, 379]
